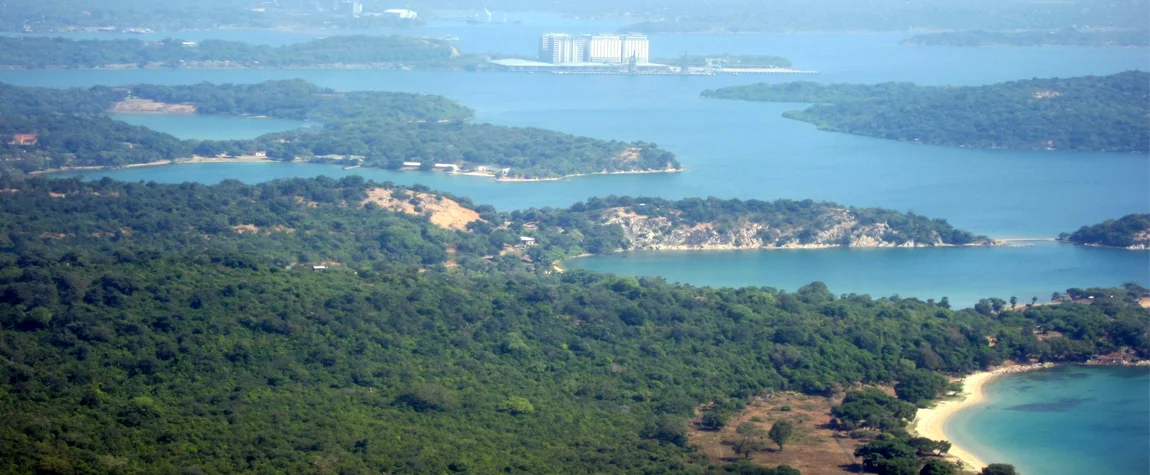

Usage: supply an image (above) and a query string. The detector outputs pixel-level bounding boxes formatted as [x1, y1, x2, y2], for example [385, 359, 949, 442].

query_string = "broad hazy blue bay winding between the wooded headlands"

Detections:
[15, 32, 1150, 305]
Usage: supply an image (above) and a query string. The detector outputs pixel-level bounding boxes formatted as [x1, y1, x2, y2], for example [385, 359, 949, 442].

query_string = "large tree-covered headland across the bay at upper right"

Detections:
[703, 71, 1150, 153]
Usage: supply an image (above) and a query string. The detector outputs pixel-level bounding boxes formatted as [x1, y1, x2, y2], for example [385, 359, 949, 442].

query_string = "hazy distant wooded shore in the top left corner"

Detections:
[0, 0, 423, 31]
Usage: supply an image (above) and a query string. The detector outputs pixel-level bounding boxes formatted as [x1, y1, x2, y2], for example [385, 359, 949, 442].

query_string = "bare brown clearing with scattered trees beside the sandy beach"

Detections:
[688, 392, 861, 475]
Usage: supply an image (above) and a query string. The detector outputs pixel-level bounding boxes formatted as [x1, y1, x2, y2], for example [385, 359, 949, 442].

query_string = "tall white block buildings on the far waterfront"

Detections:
[539, 33, 651, 64]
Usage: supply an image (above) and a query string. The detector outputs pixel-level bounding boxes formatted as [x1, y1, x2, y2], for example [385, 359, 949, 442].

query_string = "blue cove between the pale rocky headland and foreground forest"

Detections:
[565, 242, 1150, 308]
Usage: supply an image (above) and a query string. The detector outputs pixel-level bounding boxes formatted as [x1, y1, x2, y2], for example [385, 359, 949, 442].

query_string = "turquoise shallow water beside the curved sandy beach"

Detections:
[943, 366, 1150, 475]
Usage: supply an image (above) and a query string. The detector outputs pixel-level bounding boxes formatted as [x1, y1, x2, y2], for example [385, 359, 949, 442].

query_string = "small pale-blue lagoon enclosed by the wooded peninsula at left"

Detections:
[109, 114, 313, 140]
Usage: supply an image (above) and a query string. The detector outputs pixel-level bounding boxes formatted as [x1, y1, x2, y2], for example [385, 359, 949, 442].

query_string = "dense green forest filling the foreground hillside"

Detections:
[0, 177, 1150, 475]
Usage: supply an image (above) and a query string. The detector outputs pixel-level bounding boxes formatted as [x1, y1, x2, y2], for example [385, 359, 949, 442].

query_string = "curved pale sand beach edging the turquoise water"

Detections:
[912, 363, 1055, 472]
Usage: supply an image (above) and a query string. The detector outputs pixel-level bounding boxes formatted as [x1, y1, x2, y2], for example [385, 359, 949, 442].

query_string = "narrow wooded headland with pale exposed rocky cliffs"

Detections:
[506, 197, 1001, 262]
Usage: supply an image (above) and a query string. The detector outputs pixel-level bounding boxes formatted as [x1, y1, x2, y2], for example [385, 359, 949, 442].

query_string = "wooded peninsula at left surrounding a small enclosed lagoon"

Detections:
[0, 79, 682, 181]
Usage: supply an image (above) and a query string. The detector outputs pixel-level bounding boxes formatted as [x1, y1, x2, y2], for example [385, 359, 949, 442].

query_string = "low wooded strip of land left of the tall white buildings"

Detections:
[0, 36, 483, 69]
